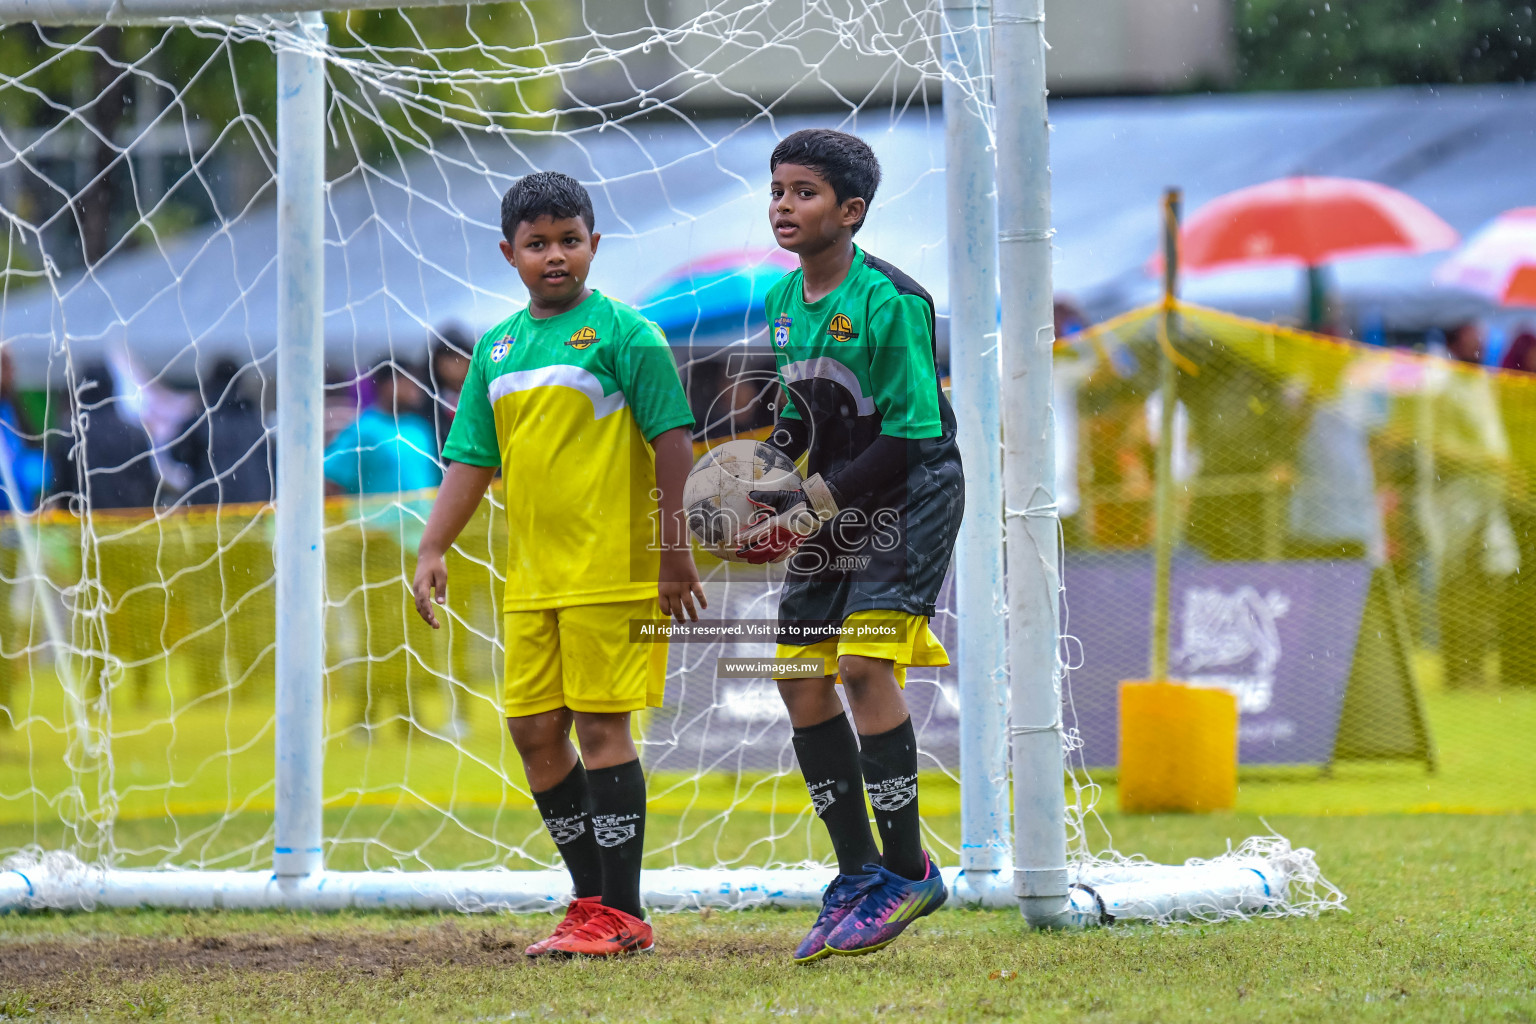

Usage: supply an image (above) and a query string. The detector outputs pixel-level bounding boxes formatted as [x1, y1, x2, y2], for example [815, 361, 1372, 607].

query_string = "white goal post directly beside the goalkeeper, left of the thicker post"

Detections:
[943, 0, 1012, 887]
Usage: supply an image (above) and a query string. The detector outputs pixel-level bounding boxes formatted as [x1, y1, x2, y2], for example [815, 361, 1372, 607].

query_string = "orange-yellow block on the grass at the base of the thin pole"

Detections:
[1120, 682, 1238, 814]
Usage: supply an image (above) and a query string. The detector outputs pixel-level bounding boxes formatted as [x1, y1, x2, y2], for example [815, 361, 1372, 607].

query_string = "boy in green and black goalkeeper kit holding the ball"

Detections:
[739, 129, 965, 963]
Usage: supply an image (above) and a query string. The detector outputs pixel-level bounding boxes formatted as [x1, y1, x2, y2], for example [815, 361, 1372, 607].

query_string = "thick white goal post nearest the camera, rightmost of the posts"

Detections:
[992, 0, 1075, 927]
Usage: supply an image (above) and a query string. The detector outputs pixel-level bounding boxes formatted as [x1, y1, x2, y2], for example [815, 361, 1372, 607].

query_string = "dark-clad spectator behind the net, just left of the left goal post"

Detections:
[170, 358, 273, 505]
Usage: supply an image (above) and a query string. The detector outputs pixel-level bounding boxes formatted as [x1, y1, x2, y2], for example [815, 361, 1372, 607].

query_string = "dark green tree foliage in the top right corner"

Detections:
[1235, 0, 1536, 89]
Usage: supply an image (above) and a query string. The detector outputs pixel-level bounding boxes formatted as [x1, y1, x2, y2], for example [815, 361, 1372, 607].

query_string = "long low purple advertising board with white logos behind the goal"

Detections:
[645, 554, 1370, 772]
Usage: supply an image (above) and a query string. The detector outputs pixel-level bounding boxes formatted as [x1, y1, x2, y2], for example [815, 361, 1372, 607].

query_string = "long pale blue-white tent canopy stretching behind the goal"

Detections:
[0, 86, 1536, 384]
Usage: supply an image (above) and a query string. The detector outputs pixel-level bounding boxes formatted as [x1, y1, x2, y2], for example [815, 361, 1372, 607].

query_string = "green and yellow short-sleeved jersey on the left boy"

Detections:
[442, 292, 693, 611]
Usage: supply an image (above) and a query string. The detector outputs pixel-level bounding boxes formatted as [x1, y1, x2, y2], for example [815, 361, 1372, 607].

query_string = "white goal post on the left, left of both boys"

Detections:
[272, 12, 326, 877]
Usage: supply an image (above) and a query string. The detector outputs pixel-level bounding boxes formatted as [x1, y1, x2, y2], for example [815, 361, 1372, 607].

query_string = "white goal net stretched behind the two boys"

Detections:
[0, 0, 1332, 913]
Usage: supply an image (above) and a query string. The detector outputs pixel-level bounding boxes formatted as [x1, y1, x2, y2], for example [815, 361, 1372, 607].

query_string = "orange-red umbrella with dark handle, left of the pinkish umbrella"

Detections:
[1154, 177, 1458, 325]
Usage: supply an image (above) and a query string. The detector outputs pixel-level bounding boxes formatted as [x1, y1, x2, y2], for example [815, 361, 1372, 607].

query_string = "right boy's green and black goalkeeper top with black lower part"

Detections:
[766, 247, 965, 628]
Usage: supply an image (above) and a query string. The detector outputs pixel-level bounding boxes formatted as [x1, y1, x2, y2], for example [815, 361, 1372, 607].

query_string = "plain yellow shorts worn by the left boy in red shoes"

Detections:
[502, 596, 667, 718]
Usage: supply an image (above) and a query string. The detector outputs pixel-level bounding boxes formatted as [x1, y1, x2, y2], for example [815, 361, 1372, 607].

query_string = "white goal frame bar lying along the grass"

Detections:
[0, 857, 1293, 927]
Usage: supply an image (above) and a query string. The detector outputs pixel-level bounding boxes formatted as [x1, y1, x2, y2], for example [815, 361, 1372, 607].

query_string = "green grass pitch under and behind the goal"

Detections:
[0, 660, 1536, 1022]
